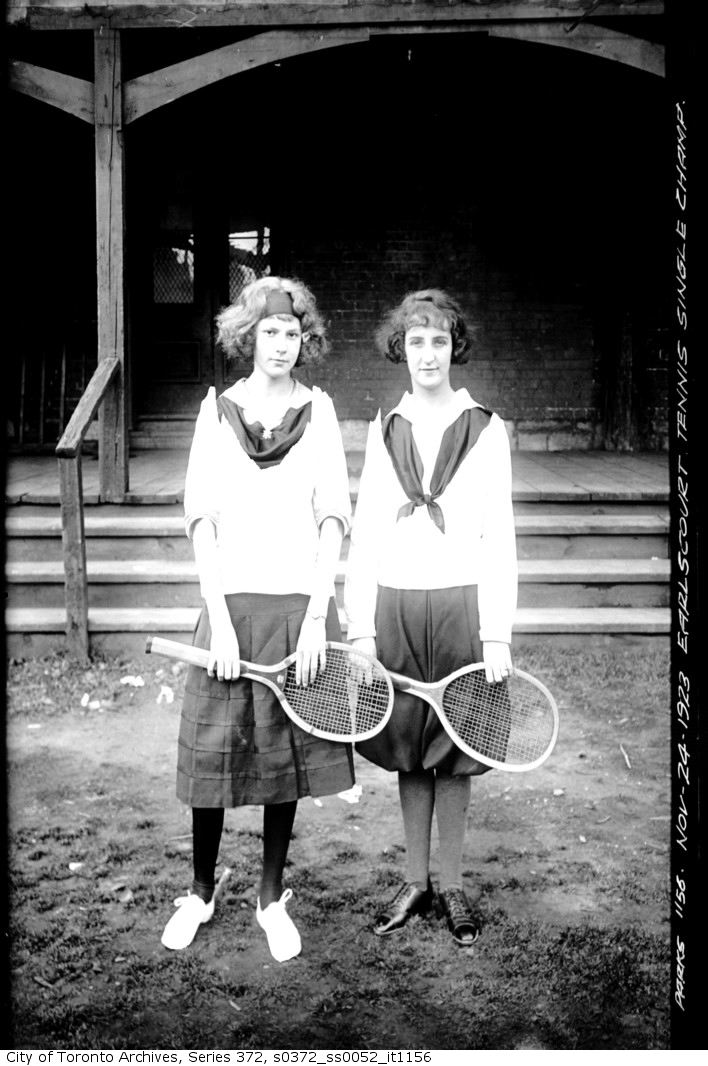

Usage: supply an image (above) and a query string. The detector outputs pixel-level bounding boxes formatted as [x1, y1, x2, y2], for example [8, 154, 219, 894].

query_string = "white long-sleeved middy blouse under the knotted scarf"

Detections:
[344, 389, 518, 644]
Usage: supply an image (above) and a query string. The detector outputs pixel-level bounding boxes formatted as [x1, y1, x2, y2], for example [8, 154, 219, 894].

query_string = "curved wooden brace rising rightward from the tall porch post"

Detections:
[125, 28, 369, 124]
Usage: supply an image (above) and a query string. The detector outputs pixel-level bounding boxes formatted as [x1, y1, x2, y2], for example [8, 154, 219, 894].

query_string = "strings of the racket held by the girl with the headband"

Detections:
[283, 648, 391, 737]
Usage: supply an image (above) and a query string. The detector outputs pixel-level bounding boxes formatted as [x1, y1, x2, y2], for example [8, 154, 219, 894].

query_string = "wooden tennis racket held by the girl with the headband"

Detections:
[146, 636, 393, 742]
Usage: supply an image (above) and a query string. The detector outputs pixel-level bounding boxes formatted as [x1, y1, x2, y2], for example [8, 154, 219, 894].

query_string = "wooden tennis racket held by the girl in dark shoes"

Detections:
[389, 663, 559, 771]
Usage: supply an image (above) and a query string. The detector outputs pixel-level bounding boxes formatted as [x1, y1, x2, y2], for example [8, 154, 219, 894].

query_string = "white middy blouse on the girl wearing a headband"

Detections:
[184, 387, 351, 595]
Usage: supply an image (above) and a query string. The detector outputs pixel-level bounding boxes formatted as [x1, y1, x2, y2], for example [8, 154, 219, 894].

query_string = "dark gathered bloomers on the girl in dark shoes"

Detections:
[356, 585, 489, 776]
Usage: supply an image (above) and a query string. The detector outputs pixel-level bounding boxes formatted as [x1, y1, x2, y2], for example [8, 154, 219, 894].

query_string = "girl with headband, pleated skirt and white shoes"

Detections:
[162, 277, 354, 962]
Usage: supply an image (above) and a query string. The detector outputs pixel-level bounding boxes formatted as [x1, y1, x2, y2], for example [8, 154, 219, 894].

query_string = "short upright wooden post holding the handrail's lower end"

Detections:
[59, 449, 89, 663]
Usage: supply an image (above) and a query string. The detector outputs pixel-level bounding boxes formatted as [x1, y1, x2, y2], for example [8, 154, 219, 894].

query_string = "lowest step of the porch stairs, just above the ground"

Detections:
[5, 608, 671, 657]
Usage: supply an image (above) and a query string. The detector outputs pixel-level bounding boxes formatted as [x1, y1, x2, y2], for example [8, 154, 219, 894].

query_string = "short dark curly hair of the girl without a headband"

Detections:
[376, 289, 469, 362]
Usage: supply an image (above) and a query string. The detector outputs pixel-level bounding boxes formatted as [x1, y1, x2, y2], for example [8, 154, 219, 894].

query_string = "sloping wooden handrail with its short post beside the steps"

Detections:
[55, 356, 120, 662]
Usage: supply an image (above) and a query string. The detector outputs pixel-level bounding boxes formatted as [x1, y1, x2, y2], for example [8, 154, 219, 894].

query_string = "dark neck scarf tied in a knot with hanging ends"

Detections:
[383, 407, 492, 533]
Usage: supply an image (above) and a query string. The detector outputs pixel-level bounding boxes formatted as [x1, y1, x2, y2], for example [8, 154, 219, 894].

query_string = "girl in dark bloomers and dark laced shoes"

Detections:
[344, 289, 517, 947]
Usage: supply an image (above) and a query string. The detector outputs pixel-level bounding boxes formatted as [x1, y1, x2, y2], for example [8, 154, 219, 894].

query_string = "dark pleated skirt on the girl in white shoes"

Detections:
[177, 593, 354, 807]
